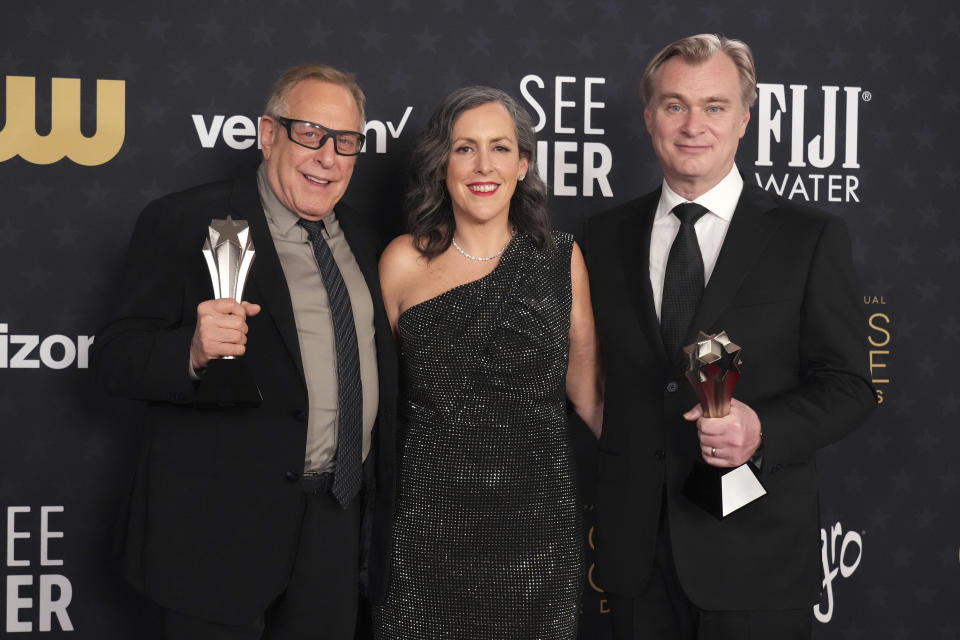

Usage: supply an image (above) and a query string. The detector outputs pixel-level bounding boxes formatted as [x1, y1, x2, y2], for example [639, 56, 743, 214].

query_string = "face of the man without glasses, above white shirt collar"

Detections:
[643, 52, 750, 200]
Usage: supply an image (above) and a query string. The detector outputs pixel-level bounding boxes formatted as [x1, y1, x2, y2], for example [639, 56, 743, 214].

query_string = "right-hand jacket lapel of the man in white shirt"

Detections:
[684, 185, 780, 344]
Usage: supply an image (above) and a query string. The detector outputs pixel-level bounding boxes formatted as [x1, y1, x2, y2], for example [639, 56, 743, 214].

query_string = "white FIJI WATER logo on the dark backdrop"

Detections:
[754, 83, 873, 202]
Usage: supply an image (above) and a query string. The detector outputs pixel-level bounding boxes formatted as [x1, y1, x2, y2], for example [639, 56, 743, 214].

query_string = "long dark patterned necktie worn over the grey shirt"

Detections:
[299, 219, 363, 507]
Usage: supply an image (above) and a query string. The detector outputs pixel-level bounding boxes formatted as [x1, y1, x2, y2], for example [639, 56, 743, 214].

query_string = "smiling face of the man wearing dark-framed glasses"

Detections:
[260, 79, 363, 220]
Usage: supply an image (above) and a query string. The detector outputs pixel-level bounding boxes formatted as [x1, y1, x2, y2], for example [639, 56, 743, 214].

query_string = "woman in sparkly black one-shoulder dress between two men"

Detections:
[373, 87, 602, 640]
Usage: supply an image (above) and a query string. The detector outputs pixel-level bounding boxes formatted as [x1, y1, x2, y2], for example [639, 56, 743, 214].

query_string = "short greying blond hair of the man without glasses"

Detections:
[640, 33, 757, 108]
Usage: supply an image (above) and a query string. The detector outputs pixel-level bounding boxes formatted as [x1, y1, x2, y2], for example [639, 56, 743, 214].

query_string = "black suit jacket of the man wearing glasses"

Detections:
[92, 174, 397, 623]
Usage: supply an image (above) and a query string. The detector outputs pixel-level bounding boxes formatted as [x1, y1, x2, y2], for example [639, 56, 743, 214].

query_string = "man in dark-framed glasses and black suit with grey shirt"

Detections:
[93, 65, 397, 640]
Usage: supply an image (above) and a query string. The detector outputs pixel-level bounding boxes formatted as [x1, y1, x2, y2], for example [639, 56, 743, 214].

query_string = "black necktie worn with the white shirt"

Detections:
[660, 202, 707, 360]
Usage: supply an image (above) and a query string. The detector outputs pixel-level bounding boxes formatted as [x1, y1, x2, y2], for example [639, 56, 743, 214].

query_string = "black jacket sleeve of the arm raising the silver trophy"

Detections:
[91, 200, 200, 404]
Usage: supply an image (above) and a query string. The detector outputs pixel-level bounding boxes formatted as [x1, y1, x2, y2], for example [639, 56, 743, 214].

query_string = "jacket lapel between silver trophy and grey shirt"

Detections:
[230, 175, 303, 378]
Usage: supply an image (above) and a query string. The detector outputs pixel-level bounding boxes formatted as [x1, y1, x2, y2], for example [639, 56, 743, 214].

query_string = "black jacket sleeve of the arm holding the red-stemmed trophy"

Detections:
[753, 216, 876, 468]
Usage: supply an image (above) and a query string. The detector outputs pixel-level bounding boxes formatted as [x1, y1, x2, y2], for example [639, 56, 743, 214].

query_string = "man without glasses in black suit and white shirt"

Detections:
[585, 35, 875, 640]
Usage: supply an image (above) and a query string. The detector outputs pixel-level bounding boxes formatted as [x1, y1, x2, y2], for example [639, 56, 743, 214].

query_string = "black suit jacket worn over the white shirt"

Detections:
[584, 185, 875, 610]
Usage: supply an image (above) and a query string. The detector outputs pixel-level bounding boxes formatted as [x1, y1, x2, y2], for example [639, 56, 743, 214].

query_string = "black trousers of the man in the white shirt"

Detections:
[607, 497, 813, 640]
